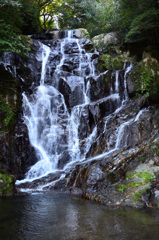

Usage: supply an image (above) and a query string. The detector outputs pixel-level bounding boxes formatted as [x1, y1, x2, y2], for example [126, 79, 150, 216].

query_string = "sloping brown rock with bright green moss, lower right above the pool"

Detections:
[61, 101, 159, 207]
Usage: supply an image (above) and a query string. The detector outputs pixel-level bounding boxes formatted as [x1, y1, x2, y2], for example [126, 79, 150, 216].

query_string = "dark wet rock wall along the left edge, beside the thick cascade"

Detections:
[0, 41, 41, 178]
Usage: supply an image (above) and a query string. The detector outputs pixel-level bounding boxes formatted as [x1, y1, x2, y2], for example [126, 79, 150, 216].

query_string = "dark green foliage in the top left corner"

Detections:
[0, 0, 33, 56]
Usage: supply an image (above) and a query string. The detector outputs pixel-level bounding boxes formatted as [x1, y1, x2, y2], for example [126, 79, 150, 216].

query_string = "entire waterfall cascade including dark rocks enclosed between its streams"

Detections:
[15, 31, 135, 188]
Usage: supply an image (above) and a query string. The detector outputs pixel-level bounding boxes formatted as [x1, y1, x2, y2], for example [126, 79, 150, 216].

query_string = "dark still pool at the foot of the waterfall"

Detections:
[0, 194, 159, 240]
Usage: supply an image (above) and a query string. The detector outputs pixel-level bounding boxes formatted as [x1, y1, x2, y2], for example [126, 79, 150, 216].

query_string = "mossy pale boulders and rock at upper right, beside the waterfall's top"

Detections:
[92, 33, 159, 103]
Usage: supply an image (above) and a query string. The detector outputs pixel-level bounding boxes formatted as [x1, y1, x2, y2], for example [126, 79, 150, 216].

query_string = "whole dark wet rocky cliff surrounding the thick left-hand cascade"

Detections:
[0, 30, 159, 207]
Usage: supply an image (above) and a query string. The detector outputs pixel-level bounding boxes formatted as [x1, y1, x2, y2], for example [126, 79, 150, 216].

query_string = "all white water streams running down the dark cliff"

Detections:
[17, 31, 134, 189]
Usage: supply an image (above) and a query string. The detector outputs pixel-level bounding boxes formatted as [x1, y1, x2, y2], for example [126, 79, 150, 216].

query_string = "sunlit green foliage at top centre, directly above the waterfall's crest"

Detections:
[54, 0, 116, 37]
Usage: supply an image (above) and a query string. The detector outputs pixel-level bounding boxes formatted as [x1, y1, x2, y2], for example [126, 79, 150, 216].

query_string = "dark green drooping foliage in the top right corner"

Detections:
[113, 0, 159, 43]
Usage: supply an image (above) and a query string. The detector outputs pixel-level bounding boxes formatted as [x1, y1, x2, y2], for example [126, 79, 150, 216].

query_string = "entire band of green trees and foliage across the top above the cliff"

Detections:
[0, 0, 159, 53]
